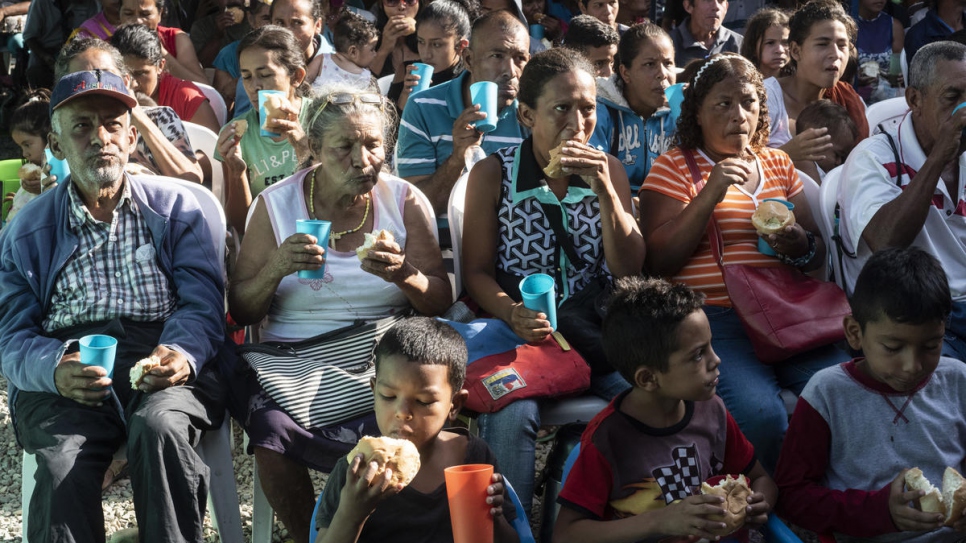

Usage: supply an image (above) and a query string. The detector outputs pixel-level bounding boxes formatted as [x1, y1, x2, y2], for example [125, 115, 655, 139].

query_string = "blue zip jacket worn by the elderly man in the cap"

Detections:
[0, 176, 225, 406]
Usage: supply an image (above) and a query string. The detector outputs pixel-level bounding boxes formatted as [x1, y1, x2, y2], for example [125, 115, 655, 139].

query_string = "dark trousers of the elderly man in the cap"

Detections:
[14, 321, 225, 543]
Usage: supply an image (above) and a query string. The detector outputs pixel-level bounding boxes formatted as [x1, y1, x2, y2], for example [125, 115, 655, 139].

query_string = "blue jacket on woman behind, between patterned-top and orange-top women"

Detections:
[590, 74, 678, 196]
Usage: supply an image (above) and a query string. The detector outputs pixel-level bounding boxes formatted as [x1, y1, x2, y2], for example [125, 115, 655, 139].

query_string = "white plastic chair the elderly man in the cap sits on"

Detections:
[20, 176, 243, 543]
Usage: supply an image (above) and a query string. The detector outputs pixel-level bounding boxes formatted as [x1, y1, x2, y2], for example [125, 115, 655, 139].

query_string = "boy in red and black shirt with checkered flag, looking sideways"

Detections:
[554, 277, 778, 543]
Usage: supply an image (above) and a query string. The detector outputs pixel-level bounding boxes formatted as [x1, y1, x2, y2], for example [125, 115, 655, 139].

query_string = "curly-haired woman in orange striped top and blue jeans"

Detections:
[640, 55, 848, 469]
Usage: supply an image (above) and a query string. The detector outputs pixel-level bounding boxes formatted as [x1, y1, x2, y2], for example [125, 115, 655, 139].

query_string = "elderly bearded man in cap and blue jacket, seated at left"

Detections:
[0, 70, 231, 542]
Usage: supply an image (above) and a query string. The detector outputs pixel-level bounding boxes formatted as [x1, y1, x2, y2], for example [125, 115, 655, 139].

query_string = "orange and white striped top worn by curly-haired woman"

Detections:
[641, 147, 802, 306]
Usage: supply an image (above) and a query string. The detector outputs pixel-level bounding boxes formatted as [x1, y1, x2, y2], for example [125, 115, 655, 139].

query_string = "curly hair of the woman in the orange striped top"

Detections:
[676, 53, 769, 152]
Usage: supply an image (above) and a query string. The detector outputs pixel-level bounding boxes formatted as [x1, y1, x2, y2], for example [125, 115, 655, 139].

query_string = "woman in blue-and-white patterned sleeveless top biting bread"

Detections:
[463, 49, 644, 507]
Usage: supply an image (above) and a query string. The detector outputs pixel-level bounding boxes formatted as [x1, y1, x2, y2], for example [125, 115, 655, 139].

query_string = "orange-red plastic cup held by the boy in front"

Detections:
[443, 464, 493, 543]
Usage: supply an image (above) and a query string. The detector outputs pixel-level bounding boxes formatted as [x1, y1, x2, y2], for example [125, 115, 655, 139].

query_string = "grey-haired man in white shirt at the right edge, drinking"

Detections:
[838, 41, 966, 360]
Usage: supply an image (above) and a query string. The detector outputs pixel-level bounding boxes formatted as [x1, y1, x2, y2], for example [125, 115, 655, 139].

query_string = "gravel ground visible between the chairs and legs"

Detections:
[0, 378, 817, 543]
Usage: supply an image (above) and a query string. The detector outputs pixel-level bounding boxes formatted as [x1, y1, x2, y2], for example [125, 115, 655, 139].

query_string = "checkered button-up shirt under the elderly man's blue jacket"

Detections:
[43, 178, 176, 332]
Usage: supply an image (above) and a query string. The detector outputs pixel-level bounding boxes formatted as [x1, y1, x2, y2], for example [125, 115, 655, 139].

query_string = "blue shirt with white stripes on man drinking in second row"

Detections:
[396, 71, 529, 177]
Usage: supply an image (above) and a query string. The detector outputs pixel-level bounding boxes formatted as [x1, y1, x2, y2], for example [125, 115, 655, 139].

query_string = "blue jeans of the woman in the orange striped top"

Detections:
[704, 306, 849, 472]
